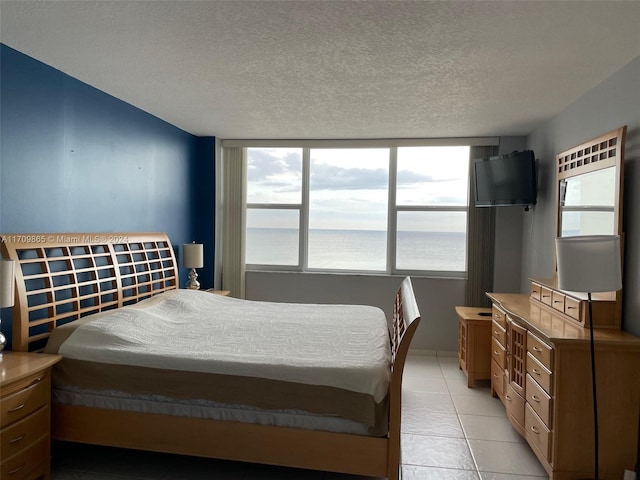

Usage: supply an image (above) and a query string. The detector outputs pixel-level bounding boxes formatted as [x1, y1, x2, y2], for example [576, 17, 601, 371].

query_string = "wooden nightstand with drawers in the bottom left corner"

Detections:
[0, 352, 62, 480]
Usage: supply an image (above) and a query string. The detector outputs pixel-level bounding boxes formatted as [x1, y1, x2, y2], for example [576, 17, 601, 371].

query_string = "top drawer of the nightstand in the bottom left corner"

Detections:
[0, 373, 50, 428]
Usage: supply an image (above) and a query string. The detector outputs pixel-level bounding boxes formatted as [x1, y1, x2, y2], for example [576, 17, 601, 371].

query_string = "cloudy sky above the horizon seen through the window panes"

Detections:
[247, 147, 469, 231]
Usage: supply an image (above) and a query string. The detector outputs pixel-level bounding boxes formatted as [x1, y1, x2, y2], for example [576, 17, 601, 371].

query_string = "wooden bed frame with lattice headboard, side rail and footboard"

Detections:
[1, 233, 420, 480]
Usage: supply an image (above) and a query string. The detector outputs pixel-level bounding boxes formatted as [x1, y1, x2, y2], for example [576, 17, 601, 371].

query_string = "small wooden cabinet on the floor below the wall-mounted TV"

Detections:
[456, 307, 491, 388]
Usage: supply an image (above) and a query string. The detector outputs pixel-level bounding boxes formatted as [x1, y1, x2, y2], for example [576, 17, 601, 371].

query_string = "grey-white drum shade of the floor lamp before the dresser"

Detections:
[556, 235, 622, 293]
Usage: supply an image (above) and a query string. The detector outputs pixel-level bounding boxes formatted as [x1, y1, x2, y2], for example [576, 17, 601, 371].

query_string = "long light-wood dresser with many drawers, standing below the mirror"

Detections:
[487, 293, 640, 480]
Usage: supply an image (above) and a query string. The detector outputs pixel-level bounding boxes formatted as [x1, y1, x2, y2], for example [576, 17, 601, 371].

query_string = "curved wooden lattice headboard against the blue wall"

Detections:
[0, 233, 178, 351]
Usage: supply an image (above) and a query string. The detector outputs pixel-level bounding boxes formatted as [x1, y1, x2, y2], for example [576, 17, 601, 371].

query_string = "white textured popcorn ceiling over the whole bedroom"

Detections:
[0, 0, 640, 138]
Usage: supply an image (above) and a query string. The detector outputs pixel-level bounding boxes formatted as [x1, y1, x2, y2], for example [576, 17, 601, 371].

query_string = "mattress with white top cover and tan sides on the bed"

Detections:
[46, 290, 390, 434]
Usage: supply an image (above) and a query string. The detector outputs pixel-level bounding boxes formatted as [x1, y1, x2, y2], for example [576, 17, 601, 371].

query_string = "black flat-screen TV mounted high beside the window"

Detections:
[473, 150, 538, 207]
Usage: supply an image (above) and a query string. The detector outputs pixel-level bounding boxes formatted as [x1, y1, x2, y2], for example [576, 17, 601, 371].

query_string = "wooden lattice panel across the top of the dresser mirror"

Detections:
[556, 126, 627, 180]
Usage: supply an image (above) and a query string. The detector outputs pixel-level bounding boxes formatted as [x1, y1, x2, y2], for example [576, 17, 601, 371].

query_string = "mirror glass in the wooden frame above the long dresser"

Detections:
[559, 167, 617, 237]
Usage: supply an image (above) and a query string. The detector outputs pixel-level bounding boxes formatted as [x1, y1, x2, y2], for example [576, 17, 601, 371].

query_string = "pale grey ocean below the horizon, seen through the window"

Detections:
[246, 228, 466, 272]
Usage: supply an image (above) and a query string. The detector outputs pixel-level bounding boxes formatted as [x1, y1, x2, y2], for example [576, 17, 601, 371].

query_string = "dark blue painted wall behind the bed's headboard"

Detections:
[0, 44, 215, 339]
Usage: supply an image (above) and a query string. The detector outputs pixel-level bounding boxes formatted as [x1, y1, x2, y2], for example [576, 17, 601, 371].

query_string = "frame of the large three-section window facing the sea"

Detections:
[232, 137, 499, 278]
